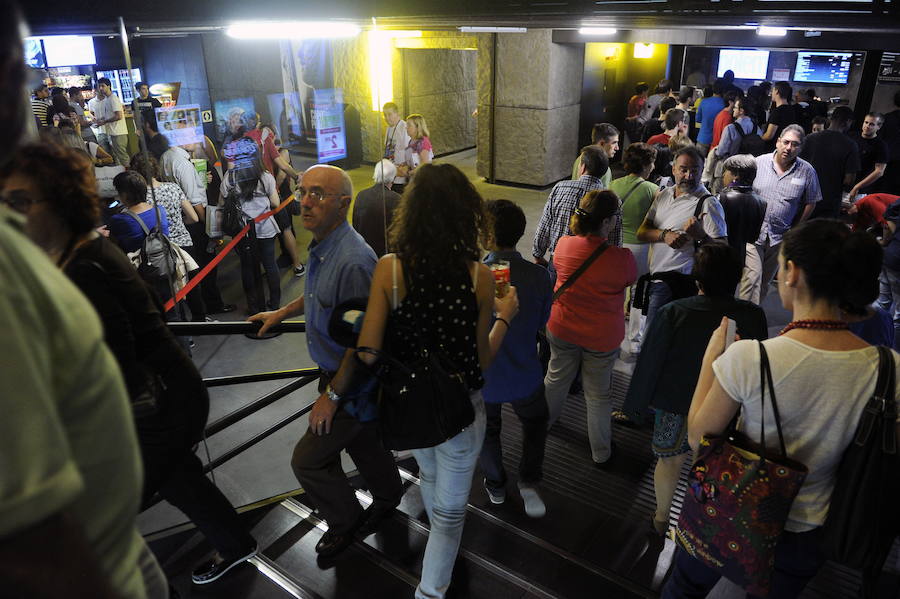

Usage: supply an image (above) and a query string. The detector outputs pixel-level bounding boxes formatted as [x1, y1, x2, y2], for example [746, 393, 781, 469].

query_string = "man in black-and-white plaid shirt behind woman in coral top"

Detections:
[531, 146, 622, 265]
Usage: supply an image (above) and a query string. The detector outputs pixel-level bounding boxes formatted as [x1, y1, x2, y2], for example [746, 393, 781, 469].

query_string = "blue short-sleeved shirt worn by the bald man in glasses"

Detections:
[304, 221, 377, 422]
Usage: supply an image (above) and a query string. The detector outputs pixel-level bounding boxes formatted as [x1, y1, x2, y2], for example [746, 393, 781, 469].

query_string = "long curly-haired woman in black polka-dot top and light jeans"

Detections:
[332, 164, 518, 599]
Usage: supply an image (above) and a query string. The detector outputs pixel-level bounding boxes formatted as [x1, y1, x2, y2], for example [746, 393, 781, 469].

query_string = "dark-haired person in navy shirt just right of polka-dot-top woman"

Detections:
[480, 200, 553, 518]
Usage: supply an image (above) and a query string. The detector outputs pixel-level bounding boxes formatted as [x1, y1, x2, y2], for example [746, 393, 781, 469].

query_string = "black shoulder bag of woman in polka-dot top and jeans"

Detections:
[356, 256, 478, 450]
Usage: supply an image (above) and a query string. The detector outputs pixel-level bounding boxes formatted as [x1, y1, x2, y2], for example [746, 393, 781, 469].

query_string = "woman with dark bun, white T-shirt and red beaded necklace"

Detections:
[662, 220, 900, 599]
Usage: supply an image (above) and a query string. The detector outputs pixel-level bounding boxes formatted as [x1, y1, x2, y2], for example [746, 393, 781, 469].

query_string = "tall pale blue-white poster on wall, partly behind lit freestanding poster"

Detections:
[272, 40, 334, 144]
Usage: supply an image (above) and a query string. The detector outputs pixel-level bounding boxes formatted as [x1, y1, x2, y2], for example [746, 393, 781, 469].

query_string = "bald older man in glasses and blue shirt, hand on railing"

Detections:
[250, 165, 403, 558]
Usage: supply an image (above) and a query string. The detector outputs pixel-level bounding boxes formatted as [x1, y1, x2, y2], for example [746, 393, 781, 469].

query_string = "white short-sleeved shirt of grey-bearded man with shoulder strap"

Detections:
[647, 185, 728, 274]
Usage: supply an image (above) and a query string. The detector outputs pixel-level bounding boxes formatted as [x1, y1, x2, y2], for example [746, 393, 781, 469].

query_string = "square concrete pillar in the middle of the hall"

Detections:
[477, 29, 584, 186]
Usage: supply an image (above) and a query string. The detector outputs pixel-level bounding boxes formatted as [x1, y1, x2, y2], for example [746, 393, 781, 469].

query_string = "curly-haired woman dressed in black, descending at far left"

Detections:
[0, 144, 256, 584]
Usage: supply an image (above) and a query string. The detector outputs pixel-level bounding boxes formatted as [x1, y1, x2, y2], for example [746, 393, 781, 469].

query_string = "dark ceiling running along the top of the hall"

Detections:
[23, 0, 900, 34]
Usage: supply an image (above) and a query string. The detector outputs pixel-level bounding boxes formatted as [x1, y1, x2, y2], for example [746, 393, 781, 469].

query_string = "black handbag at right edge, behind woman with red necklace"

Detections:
[822, 347, 900, 577]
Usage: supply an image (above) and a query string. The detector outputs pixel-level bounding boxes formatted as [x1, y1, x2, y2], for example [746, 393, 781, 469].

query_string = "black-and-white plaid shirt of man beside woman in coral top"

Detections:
[531, 175, 622, 258]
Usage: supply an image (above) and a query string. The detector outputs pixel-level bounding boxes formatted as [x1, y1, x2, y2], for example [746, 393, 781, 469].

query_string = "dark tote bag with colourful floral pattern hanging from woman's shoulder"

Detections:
[675, 342, 809, 597]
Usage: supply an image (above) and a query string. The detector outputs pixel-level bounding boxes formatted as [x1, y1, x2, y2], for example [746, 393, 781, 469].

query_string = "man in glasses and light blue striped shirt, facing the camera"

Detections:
[748, 125, 822, 302]
